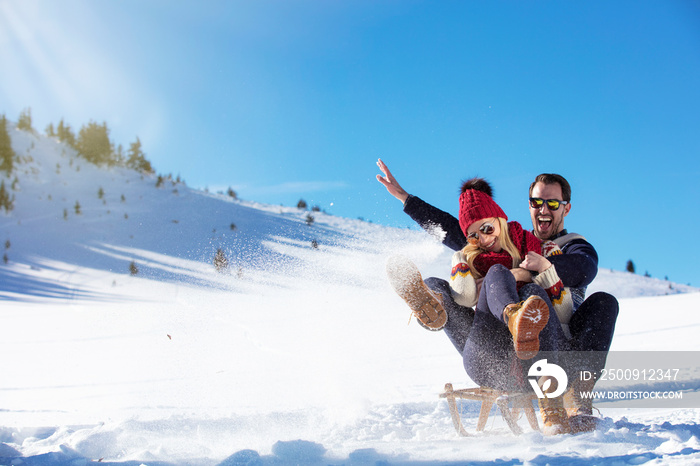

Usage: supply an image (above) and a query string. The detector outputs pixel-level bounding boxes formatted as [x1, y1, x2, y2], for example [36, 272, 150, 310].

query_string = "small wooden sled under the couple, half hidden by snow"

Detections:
[440, 383, 540, 437]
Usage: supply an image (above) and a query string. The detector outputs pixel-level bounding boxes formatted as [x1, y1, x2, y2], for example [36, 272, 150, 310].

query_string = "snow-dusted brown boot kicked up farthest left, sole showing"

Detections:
[386, 256, 447, 330]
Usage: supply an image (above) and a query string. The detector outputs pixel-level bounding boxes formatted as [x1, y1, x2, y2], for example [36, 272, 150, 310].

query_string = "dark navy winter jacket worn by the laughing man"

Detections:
[403, 195, 598, 310]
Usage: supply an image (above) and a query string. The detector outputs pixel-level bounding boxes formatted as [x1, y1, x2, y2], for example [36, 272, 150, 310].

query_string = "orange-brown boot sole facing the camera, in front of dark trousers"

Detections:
[503, 295, 549, 359]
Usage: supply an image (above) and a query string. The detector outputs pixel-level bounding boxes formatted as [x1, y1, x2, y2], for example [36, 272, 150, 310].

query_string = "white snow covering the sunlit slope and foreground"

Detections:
[0, 125, 700, 465]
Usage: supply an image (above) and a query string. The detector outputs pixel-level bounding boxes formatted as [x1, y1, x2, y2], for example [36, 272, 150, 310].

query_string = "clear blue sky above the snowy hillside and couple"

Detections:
[0, 0, 700, 286]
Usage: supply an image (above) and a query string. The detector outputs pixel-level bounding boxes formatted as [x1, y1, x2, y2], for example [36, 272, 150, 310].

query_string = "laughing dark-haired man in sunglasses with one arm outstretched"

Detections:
[377, 159, 619, 431]
